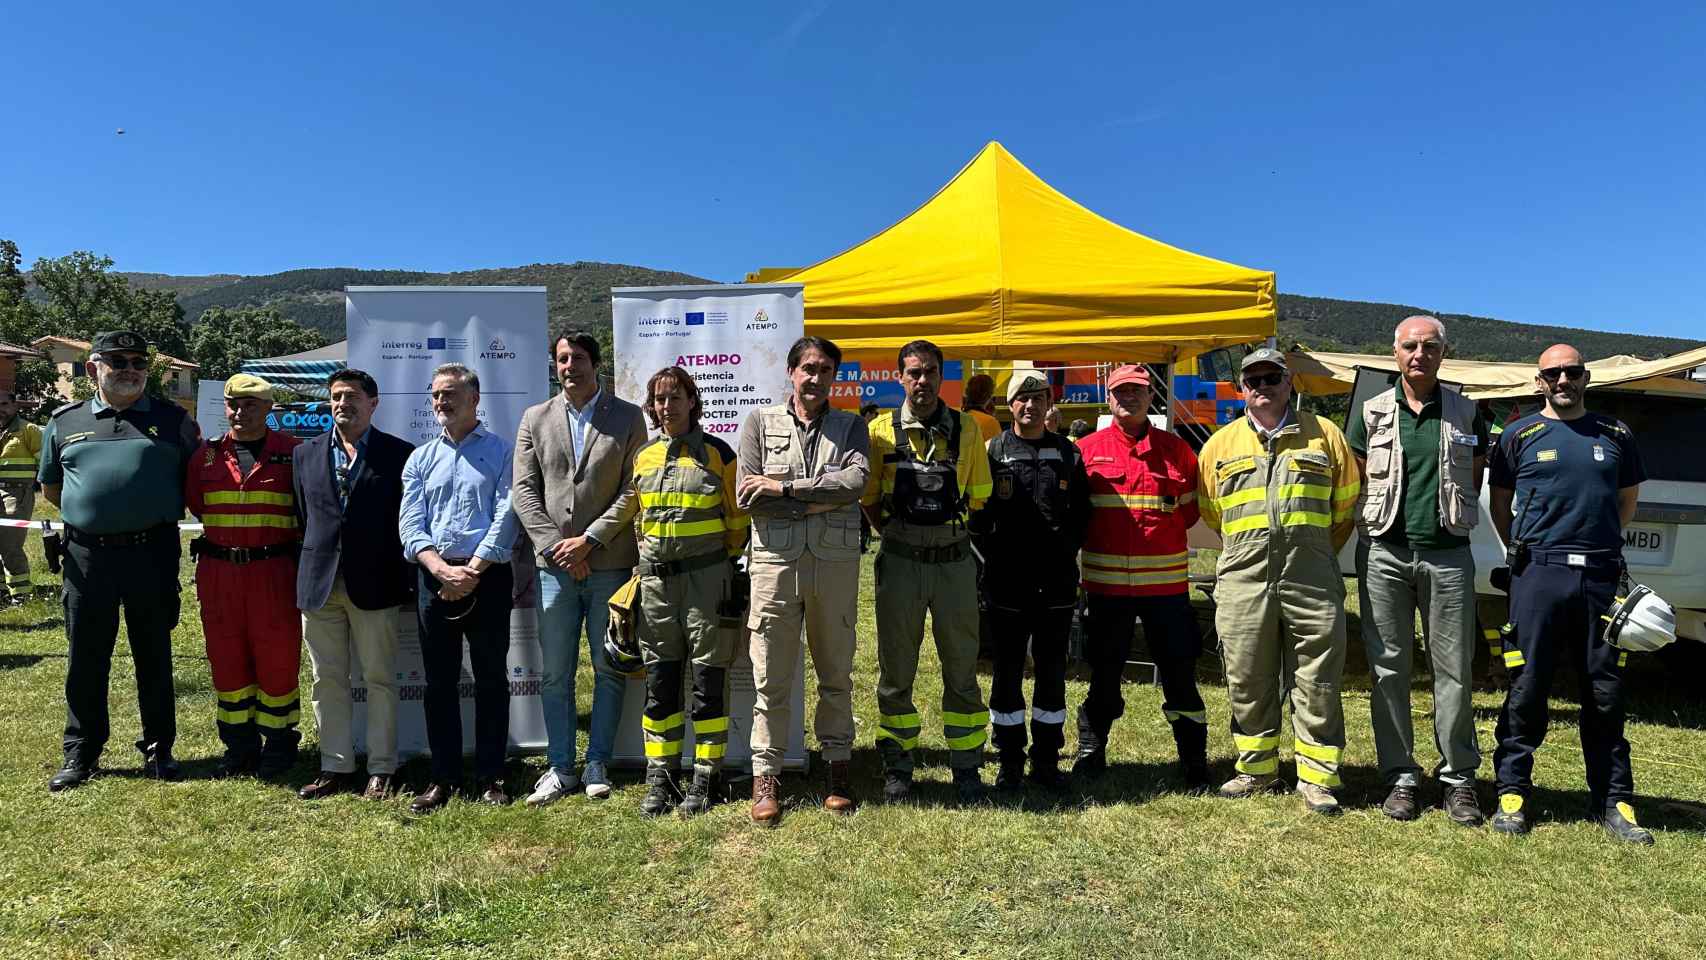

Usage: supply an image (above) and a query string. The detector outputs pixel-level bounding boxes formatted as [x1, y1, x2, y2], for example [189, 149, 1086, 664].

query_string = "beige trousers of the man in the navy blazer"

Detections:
[302, 573, 397, 776]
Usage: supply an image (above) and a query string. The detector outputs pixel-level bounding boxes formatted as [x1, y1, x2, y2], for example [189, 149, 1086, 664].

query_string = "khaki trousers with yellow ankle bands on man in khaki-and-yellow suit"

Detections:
[1215, 546, 1346, 788]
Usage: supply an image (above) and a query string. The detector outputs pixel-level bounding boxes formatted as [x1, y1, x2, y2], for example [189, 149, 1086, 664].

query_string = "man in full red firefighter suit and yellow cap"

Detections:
[184, 373, 302, 778]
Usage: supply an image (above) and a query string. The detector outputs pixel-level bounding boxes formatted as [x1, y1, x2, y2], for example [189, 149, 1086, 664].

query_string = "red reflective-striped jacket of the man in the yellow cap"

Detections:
[184, 430, 302, 547]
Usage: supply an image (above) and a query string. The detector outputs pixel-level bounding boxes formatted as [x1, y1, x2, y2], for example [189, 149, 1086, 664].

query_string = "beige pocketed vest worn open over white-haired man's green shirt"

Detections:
[1356, 387, 1481, 537]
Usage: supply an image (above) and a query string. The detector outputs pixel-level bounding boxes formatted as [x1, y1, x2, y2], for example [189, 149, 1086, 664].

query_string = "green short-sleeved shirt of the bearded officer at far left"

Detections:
[36, 397, 200, 534]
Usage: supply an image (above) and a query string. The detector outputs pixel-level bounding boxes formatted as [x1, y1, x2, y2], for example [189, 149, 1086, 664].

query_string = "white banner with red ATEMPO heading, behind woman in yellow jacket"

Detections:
[611, 283, 805, 767]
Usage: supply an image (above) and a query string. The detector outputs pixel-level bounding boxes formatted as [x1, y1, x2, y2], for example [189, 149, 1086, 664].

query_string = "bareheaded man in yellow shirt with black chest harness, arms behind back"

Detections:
[863, 339, 995, 803]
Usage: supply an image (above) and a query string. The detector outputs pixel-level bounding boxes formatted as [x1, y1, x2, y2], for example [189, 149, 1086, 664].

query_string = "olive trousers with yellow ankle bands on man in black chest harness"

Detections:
[877, 549, 989, 771]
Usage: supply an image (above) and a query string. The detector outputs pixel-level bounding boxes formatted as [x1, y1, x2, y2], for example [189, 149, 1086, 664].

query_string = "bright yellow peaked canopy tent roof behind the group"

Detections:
[747, 142, 1274, 363]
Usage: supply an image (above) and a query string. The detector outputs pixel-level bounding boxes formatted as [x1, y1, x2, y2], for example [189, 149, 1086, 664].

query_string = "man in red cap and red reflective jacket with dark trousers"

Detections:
[1073, 365, 1210, 791]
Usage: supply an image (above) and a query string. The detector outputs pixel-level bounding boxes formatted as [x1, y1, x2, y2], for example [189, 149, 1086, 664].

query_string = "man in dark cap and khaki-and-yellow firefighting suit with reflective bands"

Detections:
[1198, 348, 1361, 813]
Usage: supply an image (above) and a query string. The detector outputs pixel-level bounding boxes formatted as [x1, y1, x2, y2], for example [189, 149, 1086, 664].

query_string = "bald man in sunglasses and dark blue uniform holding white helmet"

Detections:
[1488, 344, 1653, 844]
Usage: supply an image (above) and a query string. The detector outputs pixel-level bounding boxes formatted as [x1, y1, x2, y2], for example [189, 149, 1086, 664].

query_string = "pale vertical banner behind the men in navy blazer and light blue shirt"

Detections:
[345, 286, 549, 757]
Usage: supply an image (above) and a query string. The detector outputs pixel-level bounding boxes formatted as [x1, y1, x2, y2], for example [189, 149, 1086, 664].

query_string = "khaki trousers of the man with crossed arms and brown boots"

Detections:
[747, 552, 858, 776]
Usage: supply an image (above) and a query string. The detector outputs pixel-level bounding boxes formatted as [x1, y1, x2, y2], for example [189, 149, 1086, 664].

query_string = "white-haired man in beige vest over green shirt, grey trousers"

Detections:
[1346, 315, 1488, 827]
